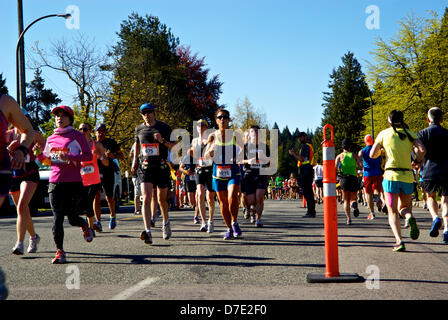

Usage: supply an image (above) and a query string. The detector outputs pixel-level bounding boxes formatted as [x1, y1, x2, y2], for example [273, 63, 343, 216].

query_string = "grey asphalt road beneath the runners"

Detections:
[0, 200, 448, 300]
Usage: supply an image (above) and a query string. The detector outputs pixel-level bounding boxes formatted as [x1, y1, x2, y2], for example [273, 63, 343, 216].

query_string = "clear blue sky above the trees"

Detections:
[0, 0, 448, 131]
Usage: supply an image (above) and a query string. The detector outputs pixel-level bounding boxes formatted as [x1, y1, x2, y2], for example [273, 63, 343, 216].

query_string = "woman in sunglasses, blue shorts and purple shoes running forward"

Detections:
[205, 108, 243, 240]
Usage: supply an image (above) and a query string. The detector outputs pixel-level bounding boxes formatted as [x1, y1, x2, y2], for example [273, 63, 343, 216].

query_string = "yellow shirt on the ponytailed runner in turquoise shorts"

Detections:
[375, 128, 417, 183]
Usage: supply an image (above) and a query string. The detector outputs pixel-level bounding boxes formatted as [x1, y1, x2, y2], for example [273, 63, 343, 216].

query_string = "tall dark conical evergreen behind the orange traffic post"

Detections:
[322, 52, 369, 150]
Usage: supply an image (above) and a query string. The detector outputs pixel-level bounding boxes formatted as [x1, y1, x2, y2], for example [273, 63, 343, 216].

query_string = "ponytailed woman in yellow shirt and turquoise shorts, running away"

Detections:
[370, 110, 426, 252]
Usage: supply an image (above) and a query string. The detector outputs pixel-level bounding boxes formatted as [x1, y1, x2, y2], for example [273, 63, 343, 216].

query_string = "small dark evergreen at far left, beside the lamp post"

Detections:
[24, 69, 61, 130]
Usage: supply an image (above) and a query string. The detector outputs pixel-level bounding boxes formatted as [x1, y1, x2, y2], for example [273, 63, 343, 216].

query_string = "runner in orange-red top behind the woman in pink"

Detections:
[78, 122, 109, 232]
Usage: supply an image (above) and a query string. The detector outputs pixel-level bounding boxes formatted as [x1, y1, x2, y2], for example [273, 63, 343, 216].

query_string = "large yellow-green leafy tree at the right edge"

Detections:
[364, 8, 448, 133]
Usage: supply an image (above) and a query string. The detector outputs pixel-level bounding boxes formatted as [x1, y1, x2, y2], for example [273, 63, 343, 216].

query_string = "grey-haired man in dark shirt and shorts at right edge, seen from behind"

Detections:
[415, 108, 448, 244]
